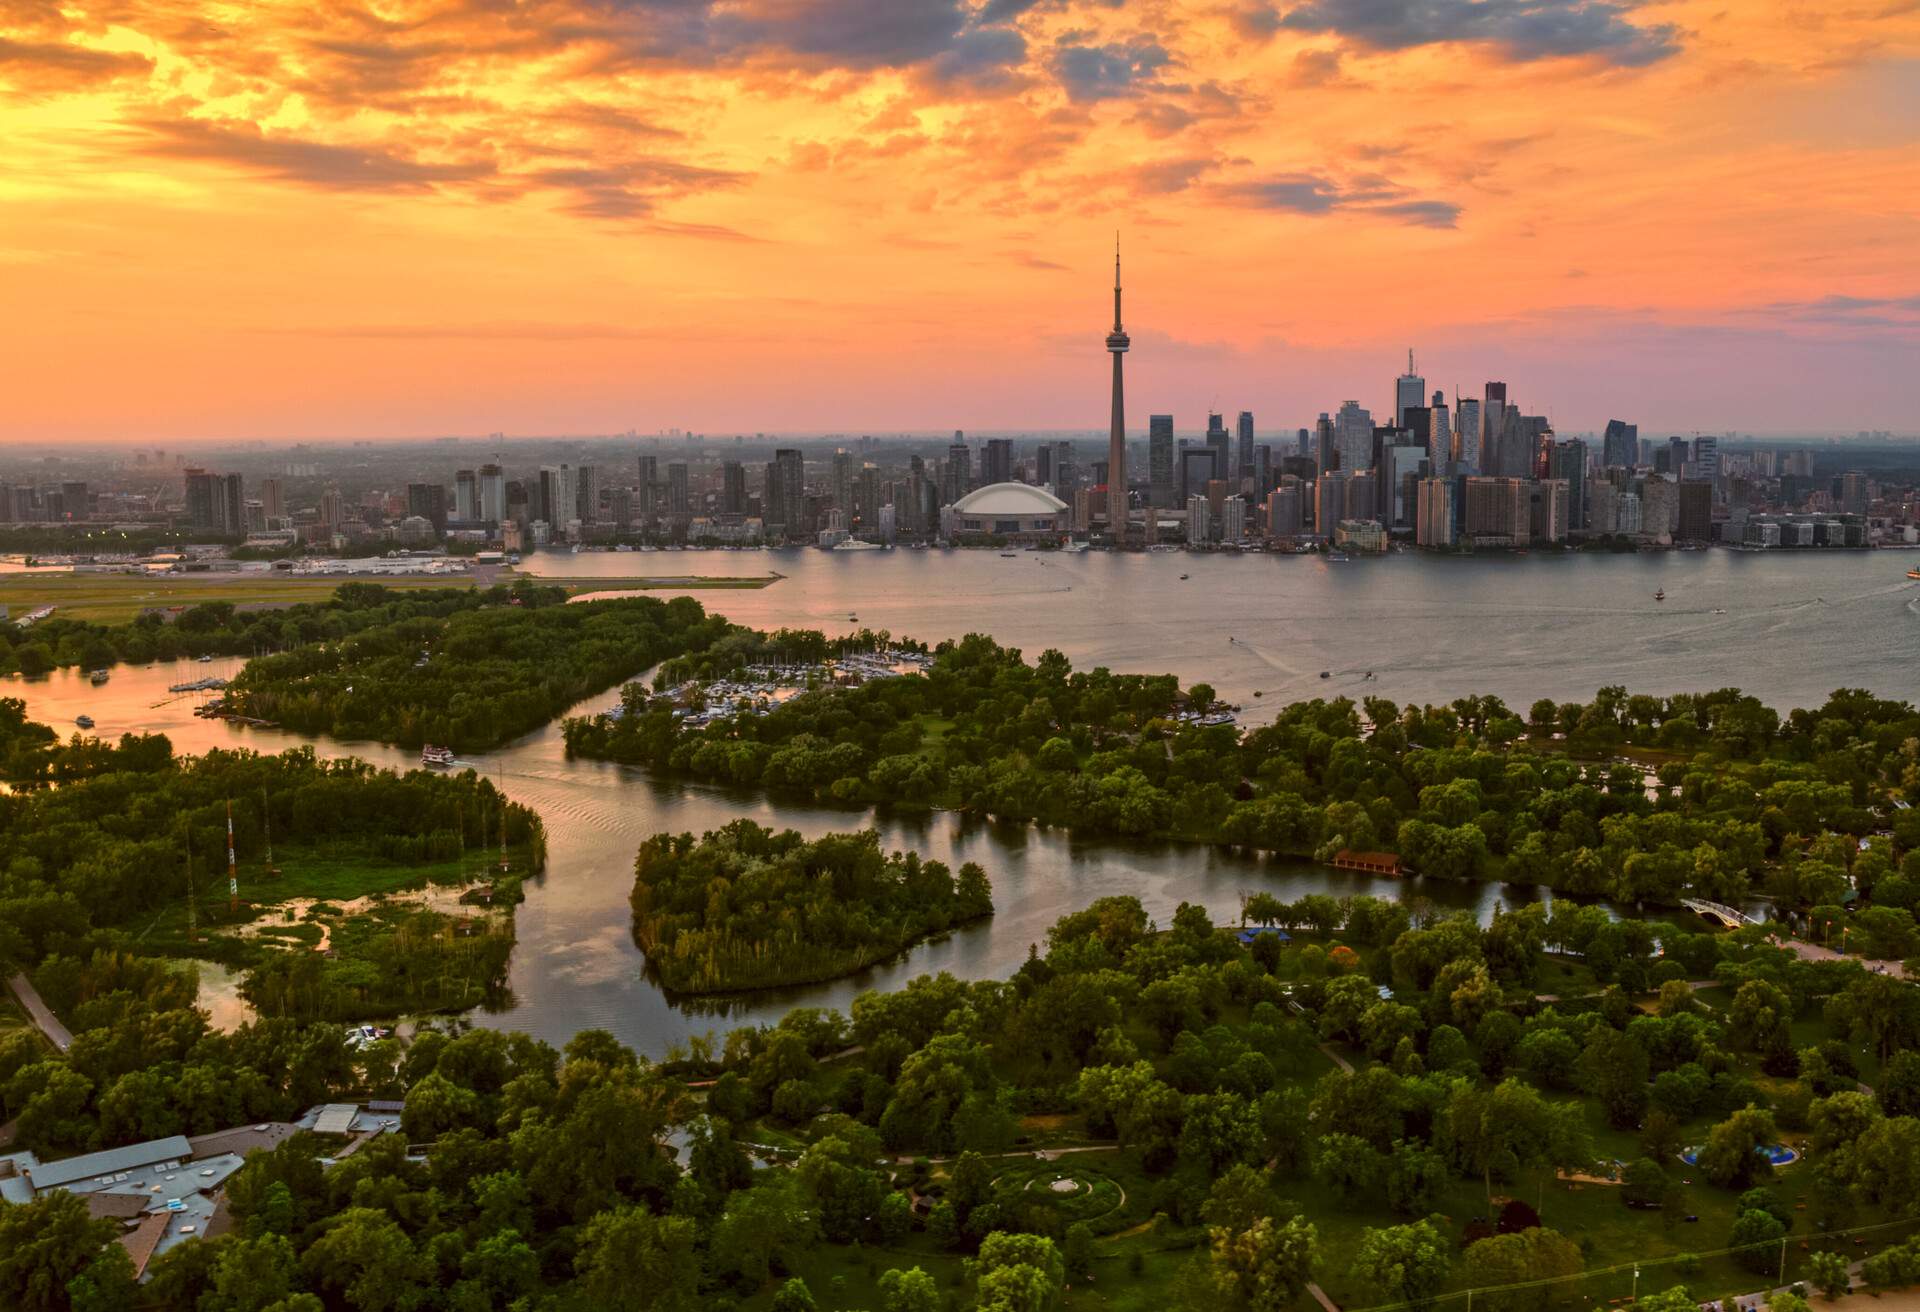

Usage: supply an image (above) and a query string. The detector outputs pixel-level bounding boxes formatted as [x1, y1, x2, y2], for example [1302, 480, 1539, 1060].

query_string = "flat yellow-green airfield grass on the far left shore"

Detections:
[0, 571, 460, 624]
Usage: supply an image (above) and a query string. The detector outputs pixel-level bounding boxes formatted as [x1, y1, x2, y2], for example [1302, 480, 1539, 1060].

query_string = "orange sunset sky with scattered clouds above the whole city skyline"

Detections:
[0, 0, 1920, 444]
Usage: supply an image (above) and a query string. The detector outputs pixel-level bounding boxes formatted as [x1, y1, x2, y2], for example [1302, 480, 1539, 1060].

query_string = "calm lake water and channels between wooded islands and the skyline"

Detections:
[0, 551, 1920, 1057]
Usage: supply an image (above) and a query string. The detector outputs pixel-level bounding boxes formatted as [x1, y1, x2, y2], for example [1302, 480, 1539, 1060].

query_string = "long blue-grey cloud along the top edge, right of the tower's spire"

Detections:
[1281, 0, 1680, 65]
